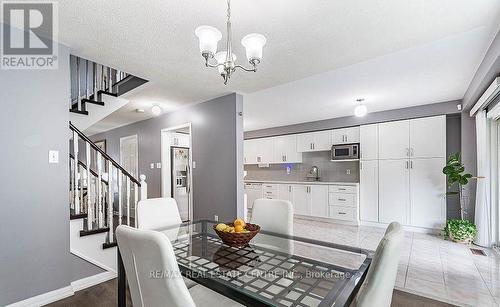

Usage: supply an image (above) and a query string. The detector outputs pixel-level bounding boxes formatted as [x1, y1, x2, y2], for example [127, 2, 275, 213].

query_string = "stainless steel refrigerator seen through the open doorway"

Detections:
[170, 146, 191, 221]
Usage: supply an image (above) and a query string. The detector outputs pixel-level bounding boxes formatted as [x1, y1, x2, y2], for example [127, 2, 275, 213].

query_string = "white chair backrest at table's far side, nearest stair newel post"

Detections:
[137, 197, 182, 229]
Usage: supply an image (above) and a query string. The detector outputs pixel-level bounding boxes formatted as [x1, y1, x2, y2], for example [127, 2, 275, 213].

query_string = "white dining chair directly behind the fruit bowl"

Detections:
[250, 198, 294, 255]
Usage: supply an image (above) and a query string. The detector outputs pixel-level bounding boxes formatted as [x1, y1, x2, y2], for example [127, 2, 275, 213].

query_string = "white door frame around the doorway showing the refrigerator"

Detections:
[160, 122, 194, 221]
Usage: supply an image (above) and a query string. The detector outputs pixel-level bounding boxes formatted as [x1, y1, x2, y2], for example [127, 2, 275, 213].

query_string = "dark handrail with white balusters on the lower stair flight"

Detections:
[69, 123, 147, 247]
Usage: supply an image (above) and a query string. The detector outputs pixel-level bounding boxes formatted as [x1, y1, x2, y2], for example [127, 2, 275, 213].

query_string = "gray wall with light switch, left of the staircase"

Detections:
[0, 28, 99, 306]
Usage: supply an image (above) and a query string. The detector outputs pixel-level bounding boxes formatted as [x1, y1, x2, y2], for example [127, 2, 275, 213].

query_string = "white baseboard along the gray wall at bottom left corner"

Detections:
[5, 272, 116, 307]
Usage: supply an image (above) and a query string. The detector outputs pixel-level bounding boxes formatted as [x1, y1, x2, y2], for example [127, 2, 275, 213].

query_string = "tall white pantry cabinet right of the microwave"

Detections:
[360, 115, 446, 228]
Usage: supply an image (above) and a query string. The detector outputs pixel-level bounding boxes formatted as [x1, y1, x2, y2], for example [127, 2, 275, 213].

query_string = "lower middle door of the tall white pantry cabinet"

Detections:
[379, 160, 410, 225]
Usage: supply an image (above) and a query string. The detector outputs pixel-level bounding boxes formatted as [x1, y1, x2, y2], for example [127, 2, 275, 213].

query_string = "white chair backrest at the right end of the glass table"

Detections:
[356, 222, 404, 307]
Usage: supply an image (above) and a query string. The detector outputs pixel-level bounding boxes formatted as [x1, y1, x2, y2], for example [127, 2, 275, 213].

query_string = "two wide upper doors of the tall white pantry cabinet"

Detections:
[378, 115, 446, 159]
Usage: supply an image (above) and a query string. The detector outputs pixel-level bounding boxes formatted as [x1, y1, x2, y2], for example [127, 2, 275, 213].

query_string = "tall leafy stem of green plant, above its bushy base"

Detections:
[443, 152, 472, 220]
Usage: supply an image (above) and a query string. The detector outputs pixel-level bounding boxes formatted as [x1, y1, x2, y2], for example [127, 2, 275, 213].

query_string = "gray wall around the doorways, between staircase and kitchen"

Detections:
[91, 93, 243, 220]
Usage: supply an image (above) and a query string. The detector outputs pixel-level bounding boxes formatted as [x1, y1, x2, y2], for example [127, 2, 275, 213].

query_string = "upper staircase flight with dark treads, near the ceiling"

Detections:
[69, 55, 148, 131]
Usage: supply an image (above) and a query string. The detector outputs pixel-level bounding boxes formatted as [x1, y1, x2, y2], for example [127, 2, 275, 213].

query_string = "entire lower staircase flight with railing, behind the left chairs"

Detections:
[69, 123, 147, 272]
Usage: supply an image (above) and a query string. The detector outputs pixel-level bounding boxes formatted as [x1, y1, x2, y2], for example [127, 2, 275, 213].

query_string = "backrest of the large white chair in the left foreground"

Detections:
[116, 225, 195, 307]
